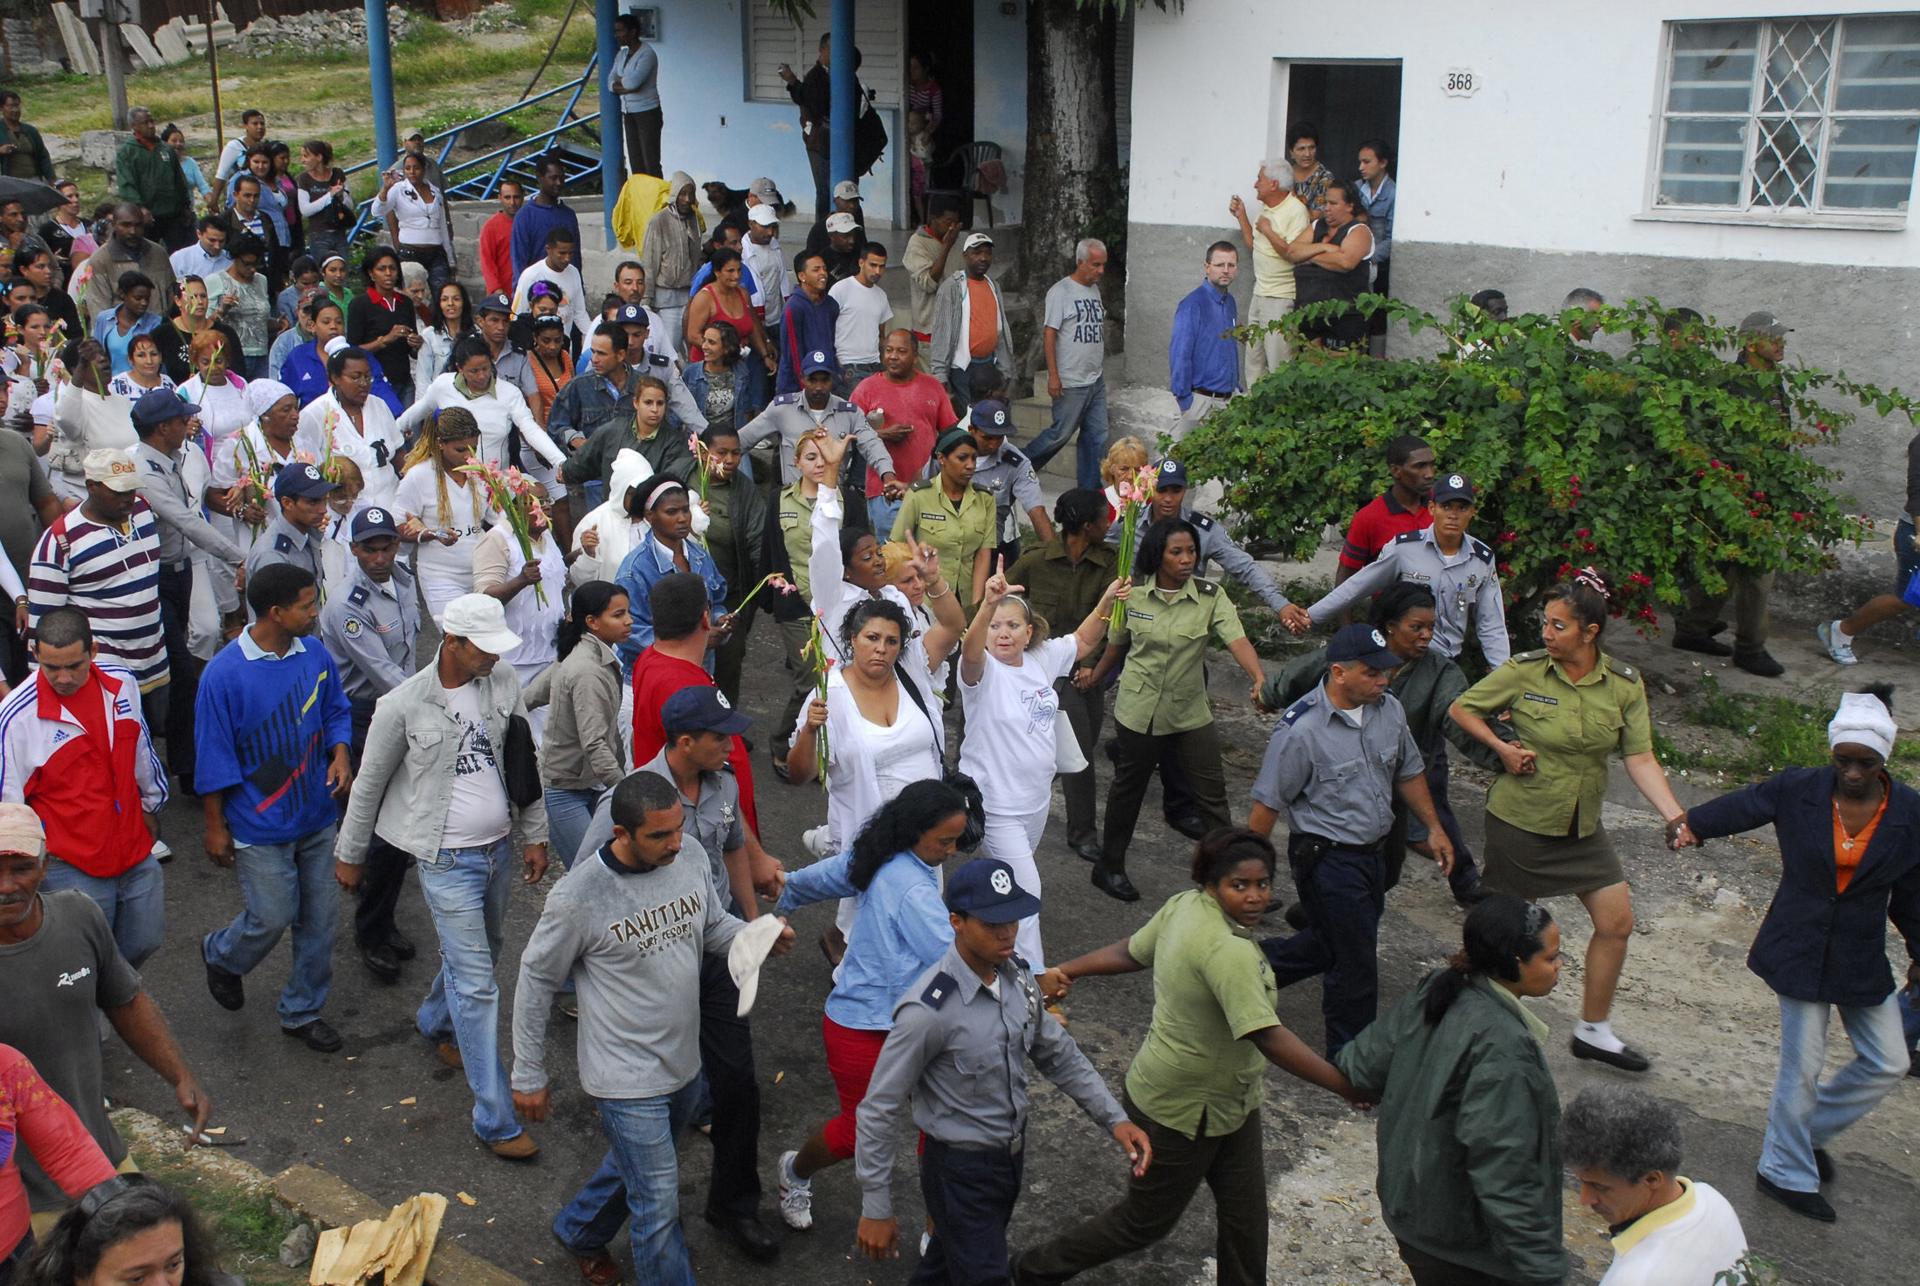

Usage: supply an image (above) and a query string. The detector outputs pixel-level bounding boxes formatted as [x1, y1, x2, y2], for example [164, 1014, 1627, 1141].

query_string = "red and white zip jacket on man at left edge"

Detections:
[0, 664, 167, 879]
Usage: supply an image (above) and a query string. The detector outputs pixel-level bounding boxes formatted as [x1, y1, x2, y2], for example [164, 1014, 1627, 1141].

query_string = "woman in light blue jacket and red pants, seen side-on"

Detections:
[774, 779, 979, 1228]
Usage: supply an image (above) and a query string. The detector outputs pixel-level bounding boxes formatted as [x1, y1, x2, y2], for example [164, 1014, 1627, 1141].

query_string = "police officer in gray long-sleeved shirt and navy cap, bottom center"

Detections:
[854, 858, 1152, 1286]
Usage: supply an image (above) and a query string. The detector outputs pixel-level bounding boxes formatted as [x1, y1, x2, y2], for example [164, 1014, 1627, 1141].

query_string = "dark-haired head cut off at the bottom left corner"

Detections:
[19, 1175, 240, 1286]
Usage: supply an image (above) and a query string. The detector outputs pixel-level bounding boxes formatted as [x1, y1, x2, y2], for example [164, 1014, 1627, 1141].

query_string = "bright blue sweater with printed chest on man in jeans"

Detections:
[194, 631, 353, 845]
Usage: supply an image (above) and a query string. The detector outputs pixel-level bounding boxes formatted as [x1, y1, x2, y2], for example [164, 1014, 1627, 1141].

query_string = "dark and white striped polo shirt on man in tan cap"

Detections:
[27, 499, 167, 693]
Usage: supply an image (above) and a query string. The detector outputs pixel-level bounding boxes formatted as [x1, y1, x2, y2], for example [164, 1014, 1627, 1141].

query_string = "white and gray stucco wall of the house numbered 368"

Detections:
[1127, 0, 1920, 514]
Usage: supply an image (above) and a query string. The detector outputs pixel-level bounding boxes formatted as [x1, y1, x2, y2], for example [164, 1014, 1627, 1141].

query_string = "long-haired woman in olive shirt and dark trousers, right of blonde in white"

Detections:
[1089, 518, 1267, 902]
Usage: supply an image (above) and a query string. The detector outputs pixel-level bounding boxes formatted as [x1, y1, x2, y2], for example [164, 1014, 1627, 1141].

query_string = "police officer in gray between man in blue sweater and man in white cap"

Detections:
[318, 510, 420, 983]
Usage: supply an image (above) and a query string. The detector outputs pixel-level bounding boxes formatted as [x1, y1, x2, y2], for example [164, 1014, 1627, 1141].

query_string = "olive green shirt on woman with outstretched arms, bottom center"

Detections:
[1127, 889, 1281, 1138]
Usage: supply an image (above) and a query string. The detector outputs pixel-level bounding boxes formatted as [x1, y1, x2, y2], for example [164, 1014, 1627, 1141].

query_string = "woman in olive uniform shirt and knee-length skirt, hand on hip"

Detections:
[1450, 568, 1686, 1071]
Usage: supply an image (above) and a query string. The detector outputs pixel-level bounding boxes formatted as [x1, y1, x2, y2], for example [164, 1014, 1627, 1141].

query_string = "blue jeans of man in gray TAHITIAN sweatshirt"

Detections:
[553, 1077, 701, 1286]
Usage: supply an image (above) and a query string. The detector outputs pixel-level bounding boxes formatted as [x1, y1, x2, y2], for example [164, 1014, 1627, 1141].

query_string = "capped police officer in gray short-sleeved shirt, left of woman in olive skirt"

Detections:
[1246, 624, 1453, 1056]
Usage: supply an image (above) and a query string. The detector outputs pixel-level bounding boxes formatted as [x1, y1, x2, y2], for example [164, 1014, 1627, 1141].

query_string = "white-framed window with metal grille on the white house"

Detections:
[1651, 13, 1920, 223]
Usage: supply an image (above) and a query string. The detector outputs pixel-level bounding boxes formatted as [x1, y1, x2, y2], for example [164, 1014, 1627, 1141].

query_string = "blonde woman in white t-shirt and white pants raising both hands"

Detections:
[960, 559, 1131, 969]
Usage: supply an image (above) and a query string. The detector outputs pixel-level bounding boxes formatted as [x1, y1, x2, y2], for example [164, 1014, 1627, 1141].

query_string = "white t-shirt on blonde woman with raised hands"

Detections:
[960, 637, 1079, 816]
